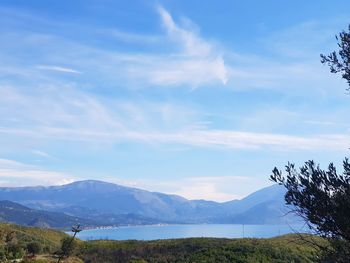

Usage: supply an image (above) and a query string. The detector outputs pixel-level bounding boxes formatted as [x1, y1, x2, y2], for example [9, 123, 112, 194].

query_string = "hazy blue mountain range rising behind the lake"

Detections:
[0, 180, 298, 228]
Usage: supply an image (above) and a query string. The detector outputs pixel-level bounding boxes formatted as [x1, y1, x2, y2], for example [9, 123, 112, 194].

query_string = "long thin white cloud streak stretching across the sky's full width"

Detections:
[0, 120, 350, 152]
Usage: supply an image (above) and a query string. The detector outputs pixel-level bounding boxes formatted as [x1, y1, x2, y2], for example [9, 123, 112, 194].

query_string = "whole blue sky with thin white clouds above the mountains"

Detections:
[0, 0, 350, 202]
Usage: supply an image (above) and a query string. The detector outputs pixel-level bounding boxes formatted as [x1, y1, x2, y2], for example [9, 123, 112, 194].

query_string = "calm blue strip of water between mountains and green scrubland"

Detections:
[77, 224, 306, 240]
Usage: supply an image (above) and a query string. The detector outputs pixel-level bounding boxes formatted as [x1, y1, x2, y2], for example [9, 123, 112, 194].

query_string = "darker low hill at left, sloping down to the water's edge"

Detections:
[0, 200, 96, 228]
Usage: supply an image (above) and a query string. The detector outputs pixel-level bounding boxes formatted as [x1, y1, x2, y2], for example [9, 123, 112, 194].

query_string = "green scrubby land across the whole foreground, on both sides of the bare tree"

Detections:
[0, 224, 325, 263]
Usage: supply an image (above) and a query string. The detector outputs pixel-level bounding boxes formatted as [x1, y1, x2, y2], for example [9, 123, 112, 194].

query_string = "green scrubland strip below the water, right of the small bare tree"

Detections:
[78, 235, 324, 263]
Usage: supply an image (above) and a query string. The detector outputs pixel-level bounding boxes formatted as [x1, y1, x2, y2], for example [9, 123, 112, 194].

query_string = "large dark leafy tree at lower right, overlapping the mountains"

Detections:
[270, 159, 350, 242]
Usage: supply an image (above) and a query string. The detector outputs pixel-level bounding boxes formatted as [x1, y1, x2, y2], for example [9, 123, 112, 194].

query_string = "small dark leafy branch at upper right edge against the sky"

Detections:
[321, 25, 350, 91]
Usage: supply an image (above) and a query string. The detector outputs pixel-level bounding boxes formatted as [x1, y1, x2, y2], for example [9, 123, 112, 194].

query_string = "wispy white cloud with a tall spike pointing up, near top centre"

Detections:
[107, 6, 229, 88]
